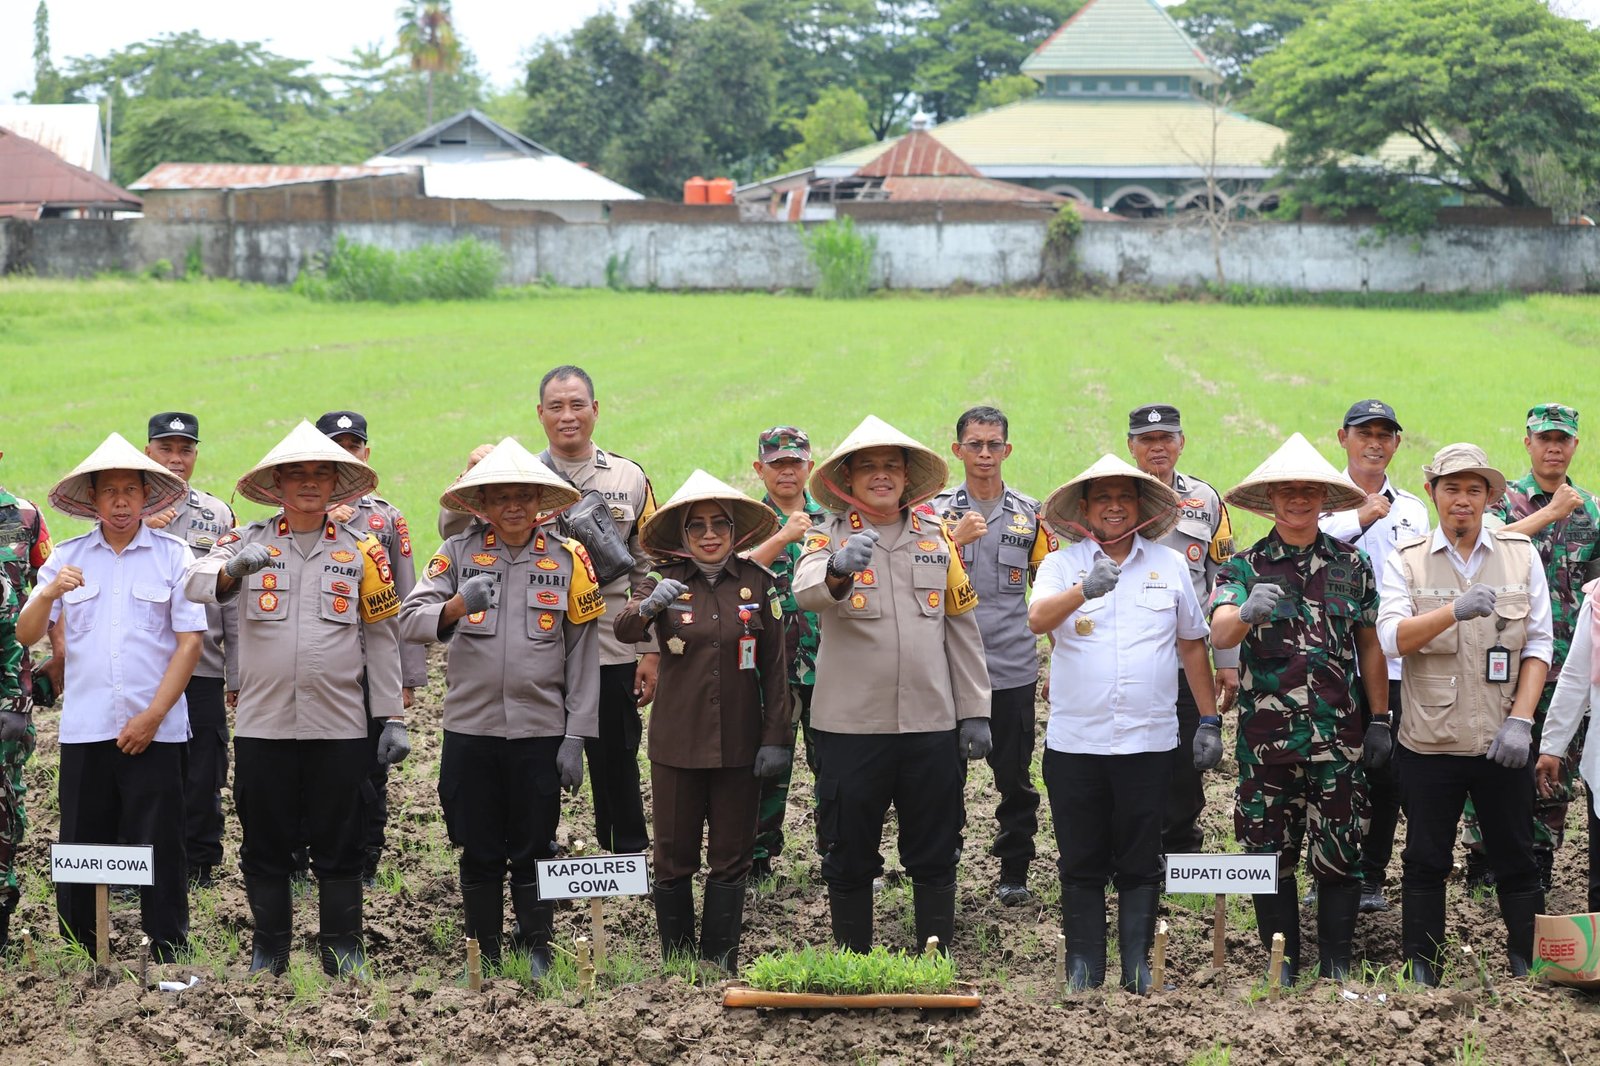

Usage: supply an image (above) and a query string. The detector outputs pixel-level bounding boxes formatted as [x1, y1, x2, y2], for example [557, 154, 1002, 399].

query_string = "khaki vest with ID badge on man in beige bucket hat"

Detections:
[1398, 530, 1533, 755]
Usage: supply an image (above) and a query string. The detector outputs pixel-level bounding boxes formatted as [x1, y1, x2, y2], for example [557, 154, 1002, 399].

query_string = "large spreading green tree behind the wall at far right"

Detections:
[1254, 0, 1600, 227]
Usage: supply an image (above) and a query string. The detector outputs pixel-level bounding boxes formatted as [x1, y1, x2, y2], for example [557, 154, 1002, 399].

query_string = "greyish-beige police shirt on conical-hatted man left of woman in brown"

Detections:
[400, 523, 605, 739]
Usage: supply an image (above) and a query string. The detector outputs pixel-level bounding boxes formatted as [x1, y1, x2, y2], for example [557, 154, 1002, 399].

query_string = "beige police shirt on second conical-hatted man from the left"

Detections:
[184, 512, 403, 739]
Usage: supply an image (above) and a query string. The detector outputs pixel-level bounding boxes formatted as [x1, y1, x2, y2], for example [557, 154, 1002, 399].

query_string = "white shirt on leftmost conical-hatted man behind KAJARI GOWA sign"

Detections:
[34, 525, 206, 744]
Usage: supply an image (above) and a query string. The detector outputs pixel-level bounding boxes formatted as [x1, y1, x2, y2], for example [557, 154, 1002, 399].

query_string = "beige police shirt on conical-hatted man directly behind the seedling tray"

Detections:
[794, 511, 989, 733]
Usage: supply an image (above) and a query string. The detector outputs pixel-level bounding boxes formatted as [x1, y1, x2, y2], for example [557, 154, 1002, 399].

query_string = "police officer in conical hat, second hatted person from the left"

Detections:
[186, 421, 411, 975]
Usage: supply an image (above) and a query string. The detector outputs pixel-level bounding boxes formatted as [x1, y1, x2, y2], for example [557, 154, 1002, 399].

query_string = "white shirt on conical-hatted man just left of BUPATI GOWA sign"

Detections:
[1034, 533, 1208, 755]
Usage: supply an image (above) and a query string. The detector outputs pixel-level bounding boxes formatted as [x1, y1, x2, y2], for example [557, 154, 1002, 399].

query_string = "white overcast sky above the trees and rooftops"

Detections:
[0, 0, 1600, 102]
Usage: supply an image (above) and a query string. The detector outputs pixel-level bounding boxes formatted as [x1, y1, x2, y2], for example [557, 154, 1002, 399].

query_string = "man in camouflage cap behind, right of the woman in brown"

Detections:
[749, 426, 827, 885]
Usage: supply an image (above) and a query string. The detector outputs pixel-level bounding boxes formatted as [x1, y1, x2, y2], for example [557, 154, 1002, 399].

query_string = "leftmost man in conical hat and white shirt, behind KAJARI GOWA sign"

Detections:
[16, 434, 206, 962]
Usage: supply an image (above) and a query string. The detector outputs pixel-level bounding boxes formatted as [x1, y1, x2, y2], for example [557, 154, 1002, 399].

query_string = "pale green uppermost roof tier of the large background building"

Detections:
[1022, 0, 1221, 83]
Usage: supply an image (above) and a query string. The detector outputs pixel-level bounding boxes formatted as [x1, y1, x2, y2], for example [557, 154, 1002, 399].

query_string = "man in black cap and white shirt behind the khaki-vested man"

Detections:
[1318, 393, 1429, 914]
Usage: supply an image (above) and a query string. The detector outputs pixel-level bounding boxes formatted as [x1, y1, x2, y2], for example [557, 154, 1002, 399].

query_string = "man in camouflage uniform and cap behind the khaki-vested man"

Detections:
[1461, 403, 1600, 892]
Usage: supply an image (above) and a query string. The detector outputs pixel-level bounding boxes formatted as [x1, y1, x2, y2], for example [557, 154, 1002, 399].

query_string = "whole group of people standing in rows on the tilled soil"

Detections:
[0, 367, 1600, 994]
